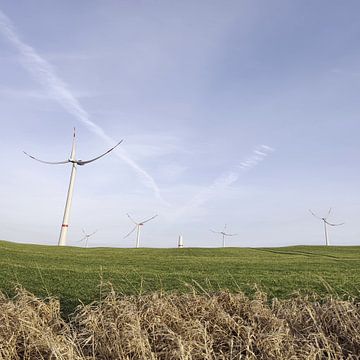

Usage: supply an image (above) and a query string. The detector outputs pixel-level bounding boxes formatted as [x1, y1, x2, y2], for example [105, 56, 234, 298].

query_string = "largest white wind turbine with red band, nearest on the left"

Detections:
[24, 128, 123, 246]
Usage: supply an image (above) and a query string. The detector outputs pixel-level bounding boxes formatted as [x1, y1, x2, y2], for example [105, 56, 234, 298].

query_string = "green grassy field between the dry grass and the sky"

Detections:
[0, 241, 360, 313]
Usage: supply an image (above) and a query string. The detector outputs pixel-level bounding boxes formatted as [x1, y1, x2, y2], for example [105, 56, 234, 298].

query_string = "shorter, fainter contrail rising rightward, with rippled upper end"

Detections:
[174, 145, 274, 218]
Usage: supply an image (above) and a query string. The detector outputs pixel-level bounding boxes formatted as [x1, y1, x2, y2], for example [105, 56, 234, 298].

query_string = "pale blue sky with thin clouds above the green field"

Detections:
[0, 0, 360, 247]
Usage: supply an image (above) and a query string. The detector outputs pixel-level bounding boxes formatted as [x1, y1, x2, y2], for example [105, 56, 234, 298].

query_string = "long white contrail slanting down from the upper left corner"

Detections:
[0, 10, 164, 201]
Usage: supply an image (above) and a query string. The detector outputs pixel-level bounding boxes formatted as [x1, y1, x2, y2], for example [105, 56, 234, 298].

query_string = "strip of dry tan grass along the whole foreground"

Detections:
[0, 288, 360, 360]
